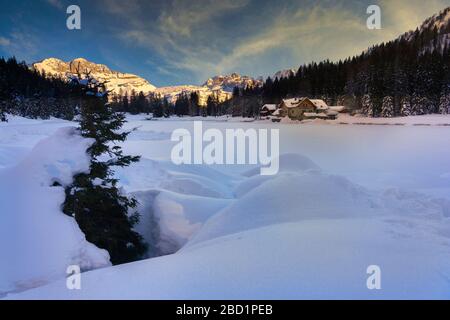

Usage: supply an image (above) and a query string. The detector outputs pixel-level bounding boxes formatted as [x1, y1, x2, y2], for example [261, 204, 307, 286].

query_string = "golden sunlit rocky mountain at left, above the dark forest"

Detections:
[33, 58, 156, 94]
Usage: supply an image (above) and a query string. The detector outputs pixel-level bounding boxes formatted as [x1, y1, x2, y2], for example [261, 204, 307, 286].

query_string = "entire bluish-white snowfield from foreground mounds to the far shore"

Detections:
[0, 116, 450, 299]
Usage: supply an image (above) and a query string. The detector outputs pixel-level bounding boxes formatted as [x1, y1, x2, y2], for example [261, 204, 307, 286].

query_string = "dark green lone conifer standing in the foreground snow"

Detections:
[63, 74, 146, 264]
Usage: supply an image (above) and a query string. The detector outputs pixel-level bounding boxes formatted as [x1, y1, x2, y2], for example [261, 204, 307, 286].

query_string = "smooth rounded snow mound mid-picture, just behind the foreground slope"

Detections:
[187, 171, 379, 246]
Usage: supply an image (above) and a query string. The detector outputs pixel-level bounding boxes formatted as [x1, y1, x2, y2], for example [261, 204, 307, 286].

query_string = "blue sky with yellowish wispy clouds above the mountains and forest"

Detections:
[0, 0, 450, 87]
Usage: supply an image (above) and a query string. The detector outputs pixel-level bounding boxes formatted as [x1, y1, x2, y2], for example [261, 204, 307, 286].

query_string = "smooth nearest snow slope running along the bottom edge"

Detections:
[6, 219, 449, 299]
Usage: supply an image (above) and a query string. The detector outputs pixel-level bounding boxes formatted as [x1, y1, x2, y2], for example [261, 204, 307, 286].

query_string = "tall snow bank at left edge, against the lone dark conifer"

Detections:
[0, 128, 110, 294]
